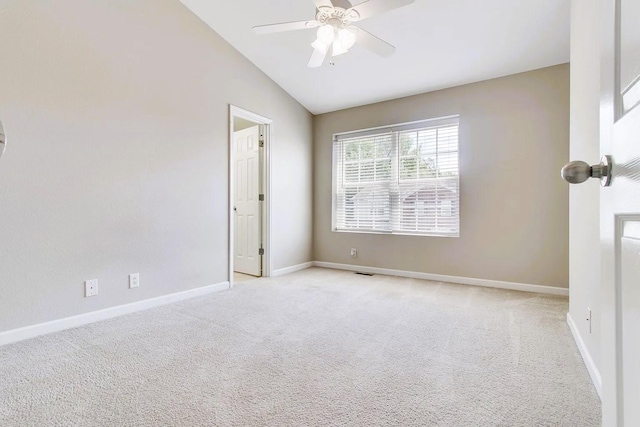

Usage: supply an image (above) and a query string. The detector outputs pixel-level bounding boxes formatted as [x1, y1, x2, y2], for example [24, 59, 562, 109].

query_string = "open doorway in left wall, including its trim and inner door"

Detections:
[229, 105, 272, 286]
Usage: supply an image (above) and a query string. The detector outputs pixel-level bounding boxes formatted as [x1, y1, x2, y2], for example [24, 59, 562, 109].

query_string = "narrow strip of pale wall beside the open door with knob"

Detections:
[569, 0, 600, 374]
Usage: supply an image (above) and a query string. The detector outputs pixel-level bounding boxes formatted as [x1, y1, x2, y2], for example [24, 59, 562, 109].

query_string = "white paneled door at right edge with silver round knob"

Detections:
[600, 0, 640, 427]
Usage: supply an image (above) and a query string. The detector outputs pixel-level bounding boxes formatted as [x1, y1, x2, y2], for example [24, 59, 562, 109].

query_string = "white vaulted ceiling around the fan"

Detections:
[181, 0, 570, 114]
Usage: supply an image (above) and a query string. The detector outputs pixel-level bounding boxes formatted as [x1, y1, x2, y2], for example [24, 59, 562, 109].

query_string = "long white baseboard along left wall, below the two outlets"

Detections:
[0, 282, 229, 346]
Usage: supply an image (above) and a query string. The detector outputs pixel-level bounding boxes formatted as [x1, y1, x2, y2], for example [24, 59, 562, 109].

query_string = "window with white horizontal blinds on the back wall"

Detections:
[333, 117, 460, 237]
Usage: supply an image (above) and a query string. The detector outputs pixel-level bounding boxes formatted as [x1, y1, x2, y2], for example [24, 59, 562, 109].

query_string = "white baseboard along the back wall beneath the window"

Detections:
[313, 261, 569, 296]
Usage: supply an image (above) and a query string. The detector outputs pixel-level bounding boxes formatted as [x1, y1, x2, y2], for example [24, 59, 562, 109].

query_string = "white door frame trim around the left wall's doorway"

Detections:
[228, 104, 273, 287]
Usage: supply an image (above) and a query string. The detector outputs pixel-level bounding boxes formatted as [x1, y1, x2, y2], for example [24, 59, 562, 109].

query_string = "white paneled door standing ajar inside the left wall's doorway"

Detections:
[233, 126, 262, 276]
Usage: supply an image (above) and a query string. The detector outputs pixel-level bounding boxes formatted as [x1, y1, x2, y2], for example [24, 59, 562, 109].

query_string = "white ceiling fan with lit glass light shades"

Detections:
[253, 0, 415, 68]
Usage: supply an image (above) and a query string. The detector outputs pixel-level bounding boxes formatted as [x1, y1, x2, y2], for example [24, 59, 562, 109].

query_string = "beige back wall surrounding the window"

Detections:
[314, 64, 569, 287]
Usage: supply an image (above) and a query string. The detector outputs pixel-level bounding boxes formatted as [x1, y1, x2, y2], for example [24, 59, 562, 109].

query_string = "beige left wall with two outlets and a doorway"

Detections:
[0, 0, 312, 331]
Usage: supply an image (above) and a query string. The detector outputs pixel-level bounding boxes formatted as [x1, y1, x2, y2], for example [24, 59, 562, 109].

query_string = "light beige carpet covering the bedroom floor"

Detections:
[0, 268, 600, 427]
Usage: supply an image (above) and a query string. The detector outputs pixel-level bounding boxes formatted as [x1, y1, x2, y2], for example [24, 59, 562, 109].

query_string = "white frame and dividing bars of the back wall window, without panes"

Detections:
[331, 115, 461, 238]
